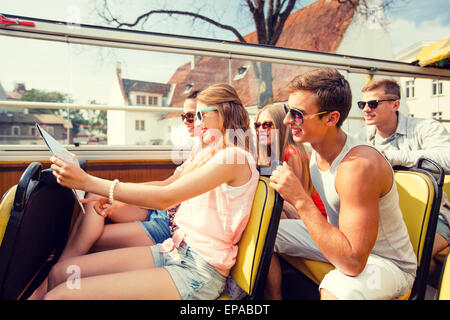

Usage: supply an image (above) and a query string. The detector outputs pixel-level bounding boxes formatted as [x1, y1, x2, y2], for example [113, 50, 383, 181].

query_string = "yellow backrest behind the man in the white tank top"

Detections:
[395, 169, 441, 300]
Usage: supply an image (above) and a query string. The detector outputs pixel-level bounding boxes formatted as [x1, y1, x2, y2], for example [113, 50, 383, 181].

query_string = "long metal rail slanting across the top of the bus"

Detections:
[0, 15, 450, 80]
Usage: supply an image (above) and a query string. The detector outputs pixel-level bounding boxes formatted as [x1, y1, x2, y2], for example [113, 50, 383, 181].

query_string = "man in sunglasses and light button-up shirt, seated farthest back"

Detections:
[358, 79, 450, 273]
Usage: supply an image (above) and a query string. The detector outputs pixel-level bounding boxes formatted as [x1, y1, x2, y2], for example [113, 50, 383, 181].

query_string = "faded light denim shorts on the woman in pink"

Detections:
[150, 243, 227, 300]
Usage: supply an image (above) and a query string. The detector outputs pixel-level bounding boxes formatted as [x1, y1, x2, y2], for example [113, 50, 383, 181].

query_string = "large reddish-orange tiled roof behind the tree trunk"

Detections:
[164, 0, 355, 111]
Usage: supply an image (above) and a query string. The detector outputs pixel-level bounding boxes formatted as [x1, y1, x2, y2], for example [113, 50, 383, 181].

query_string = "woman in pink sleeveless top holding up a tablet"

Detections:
[45, 84, 259, 299]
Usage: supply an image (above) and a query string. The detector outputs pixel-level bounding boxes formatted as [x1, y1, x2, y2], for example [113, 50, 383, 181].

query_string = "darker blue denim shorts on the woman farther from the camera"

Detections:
[138, 209, 171, 244]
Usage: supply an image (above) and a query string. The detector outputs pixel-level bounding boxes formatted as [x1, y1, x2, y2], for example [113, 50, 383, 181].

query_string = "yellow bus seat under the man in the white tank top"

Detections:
[280, 169, 438, 299]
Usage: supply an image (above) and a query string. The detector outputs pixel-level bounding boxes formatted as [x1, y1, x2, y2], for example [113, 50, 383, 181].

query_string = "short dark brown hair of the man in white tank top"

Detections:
[287, 68, 352, 127]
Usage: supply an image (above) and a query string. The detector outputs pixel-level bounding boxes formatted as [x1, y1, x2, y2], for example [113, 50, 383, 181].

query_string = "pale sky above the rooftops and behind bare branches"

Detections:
[0, 0, 450, 103]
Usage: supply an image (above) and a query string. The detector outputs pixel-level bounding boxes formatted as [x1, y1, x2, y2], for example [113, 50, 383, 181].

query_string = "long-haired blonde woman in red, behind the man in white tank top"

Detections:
[254, 104, 327, 219]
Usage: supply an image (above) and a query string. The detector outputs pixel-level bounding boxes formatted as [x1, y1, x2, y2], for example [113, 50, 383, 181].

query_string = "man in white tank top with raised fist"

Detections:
[266, 68, 417, 299]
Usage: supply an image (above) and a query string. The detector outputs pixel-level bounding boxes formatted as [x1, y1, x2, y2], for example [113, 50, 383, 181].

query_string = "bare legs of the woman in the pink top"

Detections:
[45, 247, 180, 299]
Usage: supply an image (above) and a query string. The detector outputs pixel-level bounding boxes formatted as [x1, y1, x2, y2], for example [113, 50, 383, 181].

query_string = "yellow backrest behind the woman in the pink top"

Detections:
[231, 177, 283, 299]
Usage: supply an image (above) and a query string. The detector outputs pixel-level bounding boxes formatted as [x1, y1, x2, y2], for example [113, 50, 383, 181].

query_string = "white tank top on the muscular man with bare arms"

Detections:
[310, 135, 417, 275]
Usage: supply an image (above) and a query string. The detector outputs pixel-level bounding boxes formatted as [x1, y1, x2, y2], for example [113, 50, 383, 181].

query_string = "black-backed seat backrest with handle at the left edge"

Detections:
[0, 162, 75, 300]
